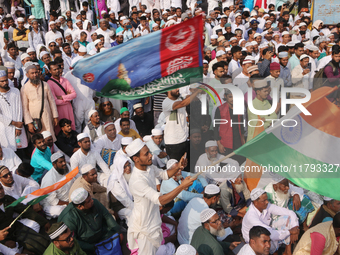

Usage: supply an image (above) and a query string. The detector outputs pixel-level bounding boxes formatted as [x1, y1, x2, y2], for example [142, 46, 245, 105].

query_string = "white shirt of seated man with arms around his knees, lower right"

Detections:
[242, 203, 299, 243]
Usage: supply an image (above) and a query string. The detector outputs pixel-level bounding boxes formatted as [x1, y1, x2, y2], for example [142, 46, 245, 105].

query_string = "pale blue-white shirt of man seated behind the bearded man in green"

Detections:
[177, 197, 209, 244]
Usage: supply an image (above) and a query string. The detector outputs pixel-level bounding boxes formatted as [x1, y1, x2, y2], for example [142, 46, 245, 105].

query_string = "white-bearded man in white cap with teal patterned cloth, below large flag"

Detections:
[264, 174, 314, 224]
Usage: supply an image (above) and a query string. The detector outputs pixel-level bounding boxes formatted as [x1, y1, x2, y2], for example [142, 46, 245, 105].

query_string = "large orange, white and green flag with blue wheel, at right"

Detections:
[234, 87, 340, 200]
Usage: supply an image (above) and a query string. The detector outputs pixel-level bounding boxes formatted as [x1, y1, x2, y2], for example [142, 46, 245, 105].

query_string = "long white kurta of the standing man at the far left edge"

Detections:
[0, 88, 27, 151]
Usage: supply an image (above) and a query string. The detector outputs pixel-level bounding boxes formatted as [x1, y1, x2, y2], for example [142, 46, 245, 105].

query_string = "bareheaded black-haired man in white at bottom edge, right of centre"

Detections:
[237, 226, 270, 255]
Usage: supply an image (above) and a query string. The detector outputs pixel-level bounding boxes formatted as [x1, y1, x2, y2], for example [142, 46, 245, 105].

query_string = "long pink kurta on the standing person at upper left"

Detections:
[47, 77, 77, 135]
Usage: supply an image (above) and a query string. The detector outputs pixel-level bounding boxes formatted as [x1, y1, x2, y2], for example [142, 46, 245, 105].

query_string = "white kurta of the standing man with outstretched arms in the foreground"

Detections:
[127, 165, 169, 255]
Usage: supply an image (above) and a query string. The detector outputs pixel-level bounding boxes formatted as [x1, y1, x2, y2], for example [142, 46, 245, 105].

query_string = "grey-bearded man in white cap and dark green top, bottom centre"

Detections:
[190, 208, 239, 255]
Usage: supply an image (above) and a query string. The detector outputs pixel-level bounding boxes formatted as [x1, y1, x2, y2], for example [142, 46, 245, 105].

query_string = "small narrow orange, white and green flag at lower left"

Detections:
[7, 167, 78, 208]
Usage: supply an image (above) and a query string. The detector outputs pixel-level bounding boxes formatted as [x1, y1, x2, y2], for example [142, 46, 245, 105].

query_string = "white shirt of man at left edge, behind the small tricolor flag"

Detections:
[2, 173, 39, 199]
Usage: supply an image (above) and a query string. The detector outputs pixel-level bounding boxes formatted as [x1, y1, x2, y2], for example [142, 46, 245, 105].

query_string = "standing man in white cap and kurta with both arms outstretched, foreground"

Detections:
[126, 138, 195, 255]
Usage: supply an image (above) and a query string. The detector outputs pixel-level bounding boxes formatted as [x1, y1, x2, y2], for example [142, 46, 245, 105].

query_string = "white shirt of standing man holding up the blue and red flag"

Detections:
[162, 97, 189, 144]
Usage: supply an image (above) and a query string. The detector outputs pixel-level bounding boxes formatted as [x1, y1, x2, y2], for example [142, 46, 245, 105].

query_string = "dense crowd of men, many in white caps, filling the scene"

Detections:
[0, 0, 340, 255]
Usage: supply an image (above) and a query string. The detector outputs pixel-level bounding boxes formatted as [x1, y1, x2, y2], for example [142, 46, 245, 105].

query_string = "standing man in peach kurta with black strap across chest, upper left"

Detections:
[21, 65, 58, 141]
